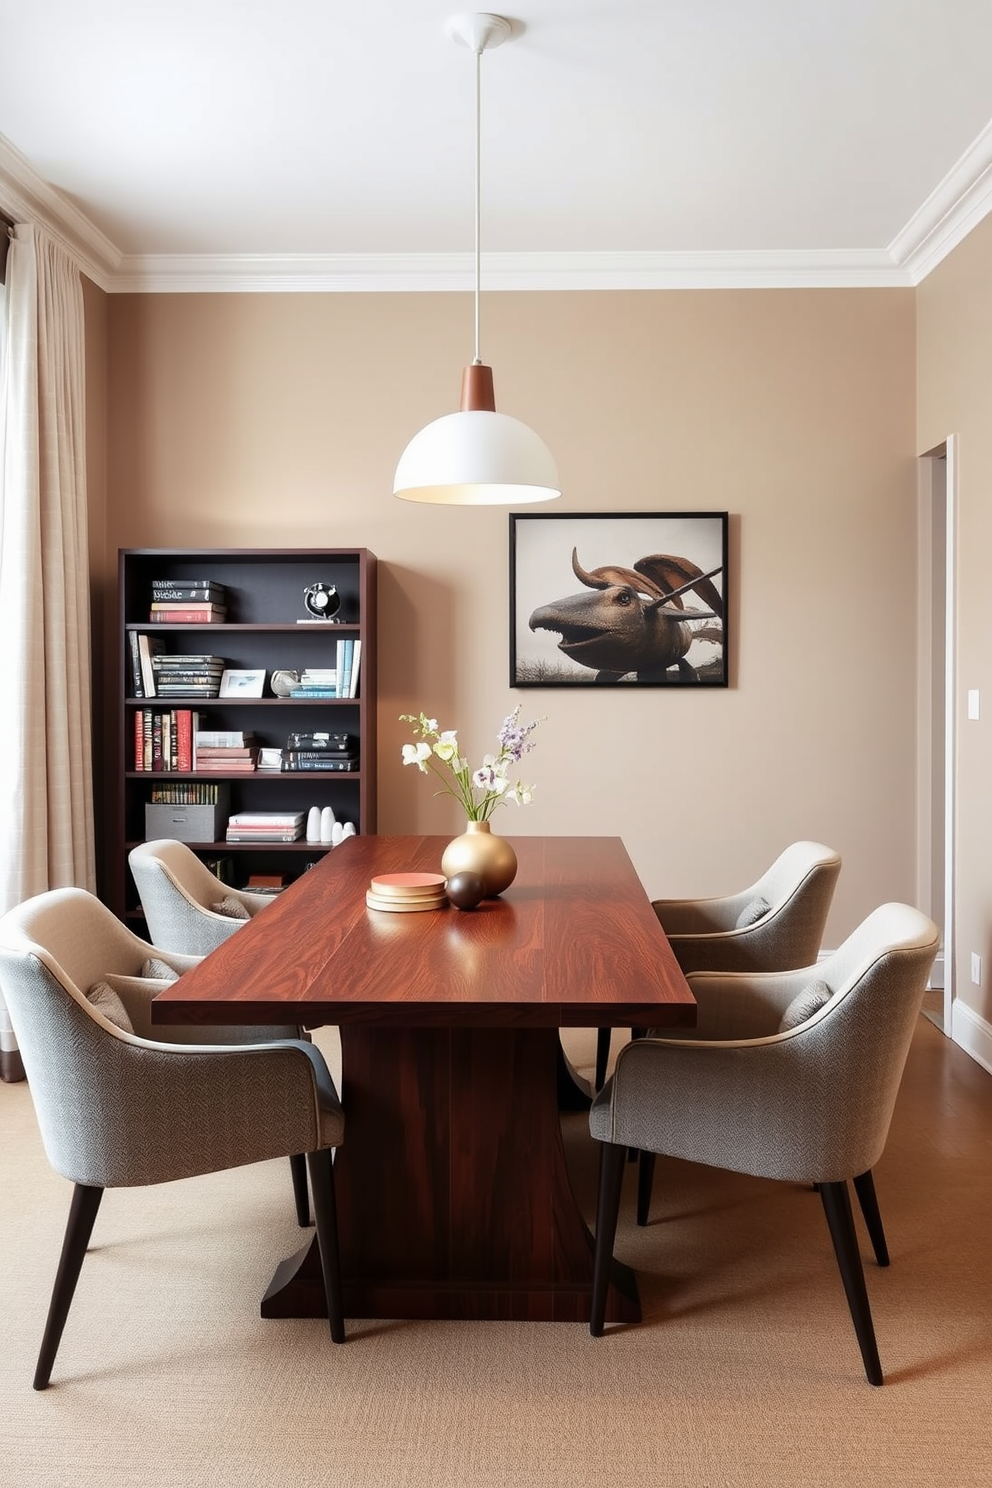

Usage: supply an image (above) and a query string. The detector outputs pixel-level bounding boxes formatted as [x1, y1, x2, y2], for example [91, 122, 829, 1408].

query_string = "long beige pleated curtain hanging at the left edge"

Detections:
[0, 225, 95, 1079]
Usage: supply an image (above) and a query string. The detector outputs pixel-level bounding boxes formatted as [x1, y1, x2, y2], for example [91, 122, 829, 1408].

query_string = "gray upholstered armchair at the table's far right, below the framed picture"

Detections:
[596, 842, 840, 1089]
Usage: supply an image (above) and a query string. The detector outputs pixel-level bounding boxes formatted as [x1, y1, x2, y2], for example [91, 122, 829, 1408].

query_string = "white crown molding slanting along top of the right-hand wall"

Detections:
[888, 122, 992, 284]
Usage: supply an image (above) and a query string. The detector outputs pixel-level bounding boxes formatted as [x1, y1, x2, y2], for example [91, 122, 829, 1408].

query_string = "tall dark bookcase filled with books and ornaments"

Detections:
[111, 548, 376, 917]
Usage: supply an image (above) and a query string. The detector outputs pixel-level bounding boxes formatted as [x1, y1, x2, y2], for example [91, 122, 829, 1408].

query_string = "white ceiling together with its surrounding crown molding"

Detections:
[0, 0, 992, 289]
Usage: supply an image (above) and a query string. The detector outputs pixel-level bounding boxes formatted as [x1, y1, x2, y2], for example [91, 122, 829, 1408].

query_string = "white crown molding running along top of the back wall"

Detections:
[109, 250, 912, 295]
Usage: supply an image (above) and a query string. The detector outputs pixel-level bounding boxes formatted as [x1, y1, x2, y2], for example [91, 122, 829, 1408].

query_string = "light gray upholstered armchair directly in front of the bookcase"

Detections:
[128, 838, 279, 955]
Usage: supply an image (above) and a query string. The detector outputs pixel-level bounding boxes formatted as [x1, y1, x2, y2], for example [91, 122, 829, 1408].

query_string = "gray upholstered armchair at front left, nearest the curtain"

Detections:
[0, 888, 345, 1390]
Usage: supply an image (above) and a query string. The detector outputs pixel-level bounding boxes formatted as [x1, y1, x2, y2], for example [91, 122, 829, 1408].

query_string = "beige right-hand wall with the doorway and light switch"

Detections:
[918, 217, 992, 1021]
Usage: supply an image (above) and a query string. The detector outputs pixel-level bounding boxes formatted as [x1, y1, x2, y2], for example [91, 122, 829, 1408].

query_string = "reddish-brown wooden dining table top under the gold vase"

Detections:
[152, 836, 696, 1028]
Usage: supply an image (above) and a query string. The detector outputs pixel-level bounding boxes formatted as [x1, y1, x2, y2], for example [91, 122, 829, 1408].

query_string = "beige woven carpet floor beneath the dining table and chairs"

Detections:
[0, 1019, 992, 1488]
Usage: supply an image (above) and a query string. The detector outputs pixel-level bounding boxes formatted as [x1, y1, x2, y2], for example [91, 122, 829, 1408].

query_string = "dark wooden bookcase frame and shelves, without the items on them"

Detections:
[114, 548, 376, 923]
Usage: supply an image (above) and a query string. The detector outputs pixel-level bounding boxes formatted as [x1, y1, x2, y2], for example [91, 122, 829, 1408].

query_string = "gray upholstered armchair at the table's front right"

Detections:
[589, 903, 938, 1385]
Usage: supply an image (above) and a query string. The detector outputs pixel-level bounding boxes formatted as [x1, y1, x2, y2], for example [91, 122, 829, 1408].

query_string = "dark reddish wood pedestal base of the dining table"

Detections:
[262, 1025, 640, 1321]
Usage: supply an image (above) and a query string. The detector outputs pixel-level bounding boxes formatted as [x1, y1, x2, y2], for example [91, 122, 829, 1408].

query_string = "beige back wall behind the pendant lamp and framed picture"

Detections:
[107, 281, 922, 943]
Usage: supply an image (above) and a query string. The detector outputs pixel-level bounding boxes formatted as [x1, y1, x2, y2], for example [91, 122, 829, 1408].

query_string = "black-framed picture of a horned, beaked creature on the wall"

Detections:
[510, 512, 729, 687]
